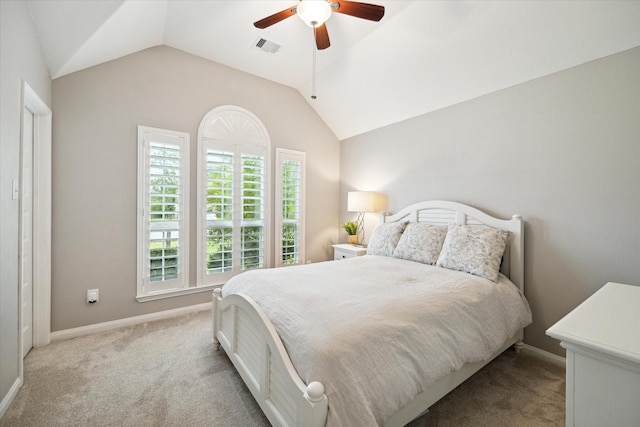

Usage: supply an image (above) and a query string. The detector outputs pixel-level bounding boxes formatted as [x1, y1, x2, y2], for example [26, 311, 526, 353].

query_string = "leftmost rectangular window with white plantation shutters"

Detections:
[137, 126, 189, 300]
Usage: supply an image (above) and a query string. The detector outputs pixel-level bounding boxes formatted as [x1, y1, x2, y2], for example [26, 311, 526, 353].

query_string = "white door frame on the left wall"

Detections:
[18, 80, 52, 362]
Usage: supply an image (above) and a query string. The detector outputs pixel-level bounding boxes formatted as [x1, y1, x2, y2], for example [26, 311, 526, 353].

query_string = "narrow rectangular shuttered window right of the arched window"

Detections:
[275, 148, 305, 266]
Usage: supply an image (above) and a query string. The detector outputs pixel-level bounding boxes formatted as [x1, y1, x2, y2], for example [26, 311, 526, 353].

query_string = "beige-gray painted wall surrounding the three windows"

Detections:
[52, 46, 340, 331]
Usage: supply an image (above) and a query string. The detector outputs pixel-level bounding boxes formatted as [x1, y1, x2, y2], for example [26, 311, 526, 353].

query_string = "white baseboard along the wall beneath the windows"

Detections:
[51, 302, 211, 341]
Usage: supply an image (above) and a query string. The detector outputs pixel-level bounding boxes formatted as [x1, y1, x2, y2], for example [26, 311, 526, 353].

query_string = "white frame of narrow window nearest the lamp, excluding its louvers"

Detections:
[274, 147, 306, 267]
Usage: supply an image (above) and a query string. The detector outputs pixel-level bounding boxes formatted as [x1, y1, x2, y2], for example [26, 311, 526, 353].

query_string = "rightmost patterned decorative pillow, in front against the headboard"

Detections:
[436, 224, 509, 282]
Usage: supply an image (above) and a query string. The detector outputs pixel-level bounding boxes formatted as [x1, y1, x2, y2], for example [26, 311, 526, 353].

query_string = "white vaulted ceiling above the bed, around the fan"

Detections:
[29, 0, 640, 140]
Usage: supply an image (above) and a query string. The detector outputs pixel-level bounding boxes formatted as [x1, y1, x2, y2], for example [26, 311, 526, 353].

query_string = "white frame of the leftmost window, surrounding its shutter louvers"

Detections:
[136, 126, 190, 302]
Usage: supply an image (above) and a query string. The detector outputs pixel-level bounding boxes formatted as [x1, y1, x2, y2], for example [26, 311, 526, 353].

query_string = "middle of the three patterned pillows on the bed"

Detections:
[393, 222, 447, 265]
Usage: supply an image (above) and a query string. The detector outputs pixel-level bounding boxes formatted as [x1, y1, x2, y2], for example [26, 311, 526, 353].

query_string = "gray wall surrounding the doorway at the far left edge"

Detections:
[0, 0, 51, 414]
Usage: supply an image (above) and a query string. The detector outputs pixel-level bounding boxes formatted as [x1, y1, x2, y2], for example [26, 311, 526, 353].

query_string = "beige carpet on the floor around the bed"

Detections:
[0, 311, 564, 427]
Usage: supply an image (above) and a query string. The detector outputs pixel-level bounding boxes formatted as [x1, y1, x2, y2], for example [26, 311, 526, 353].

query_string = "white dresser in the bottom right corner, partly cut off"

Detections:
[547, 283, 640, 427]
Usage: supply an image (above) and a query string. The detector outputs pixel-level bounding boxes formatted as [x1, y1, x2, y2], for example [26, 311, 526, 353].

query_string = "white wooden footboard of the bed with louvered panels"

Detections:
[212, 289, 328, 427]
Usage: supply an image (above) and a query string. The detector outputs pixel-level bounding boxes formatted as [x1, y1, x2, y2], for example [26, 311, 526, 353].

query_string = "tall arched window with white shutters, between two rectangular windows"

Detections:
[196, 106, 272, 286]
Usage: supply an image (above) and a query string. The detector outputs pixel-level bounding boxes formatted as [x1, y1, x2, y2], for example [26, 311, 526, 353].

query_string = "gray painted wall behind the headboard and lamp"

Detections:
[340, 48, 640, 354]
